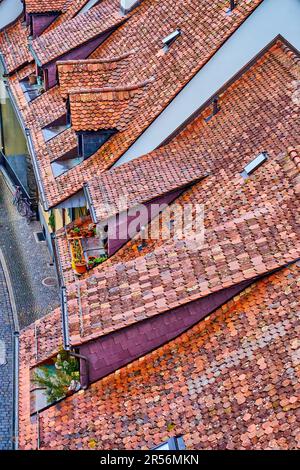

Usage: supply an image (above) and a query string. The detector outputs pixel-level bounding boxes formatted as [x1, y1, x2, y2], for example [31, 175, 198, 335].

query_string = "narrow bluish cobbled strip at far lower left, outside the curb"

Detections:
[0, 261, 13, 450]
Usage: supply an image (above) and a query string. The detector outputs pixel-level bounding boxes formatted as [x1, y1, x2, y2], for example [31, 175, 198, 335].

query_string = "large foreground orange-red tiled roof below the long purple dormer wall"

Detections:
[20, 264, 300, 450]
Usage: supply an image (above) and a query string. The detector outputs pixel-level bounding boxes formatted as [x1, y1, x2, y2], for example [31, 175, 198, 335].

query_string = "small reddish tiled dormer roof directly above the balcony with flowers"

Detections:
[88, 145, 207, 221]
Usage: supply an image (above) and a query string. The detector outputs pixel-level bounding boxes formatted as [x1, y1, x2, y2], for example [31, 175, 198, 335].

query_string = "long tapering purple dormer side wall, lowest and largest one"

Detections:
[80, 280, 253, 386]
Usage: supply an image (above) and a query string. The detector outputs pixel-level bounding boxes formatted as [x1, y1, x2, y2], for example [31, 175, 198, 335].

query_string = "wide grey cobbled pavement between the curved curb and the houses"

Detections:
[0, 172, 59, 328]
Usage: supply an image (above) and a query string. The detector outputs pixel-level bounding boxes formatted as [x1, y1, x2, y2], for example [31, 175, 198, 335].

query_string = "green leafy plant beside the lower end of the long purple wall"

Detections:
[33, 350, 80, 403]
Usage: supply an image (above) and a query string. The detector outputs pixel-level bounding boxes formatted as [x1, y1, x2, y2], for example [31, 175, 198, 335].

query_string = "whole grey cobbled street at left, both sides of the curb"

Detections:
[0, 172, 59, 450]
